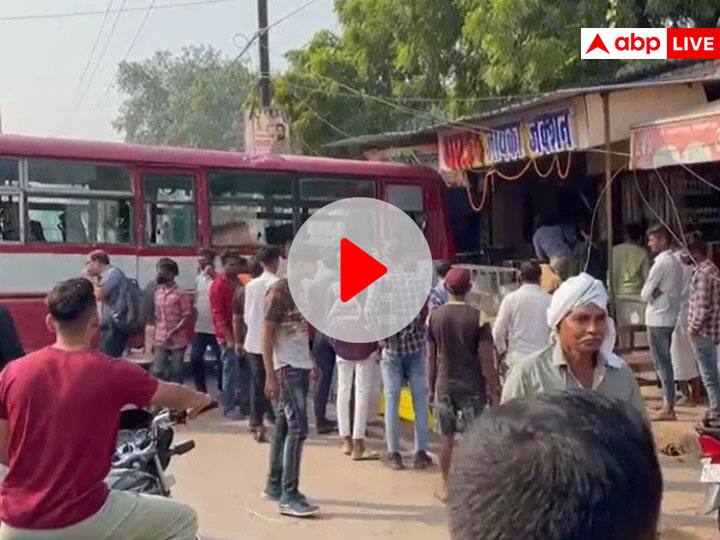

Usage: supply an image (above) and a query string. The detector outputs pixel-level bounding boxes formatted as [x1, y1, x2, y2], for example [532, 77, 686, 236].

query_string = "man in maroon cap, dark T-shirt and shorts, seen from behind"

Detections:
[427, 268, 500, 502]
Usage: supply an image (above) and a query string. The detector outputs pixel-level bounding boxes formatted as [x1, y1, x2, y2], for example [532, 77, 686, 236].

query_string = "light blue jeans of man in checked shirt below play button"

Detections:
[380, 349, 428, 453]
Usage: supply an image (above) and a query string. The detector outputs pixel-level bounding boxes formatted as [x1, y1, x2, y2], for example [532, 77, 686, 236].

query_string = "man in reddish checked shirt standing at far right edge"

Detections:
[688, 240, 720, 414]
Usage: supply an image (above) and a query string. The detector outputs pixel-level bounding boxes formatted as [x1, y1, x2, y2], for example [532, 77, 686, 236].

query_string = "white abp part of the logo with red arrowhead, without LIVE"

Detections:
[580, 28, 667, 60]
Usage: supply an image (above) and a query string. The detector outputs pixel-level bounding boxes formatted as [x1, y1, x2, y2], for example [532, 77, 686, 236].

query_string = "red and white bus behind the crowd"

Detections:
[0, 135, 454, 350]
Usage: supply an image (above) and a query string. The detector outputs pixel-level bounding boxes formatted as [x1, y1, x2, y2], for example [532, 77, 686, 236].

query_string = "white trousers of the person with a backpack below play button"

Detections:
[336, 356, 375, 439]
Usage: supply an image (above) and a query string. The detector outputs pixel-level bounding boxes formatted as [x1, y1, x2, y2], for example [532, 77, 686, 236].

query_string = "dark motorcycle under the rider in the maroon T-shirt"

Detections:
[105, 402, 218, 497]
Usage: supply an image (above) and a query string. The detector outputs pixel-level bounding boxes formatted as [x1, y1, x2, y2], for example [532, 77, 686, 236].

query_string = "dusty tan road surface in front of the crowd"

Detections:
[172, 412, 718, 540]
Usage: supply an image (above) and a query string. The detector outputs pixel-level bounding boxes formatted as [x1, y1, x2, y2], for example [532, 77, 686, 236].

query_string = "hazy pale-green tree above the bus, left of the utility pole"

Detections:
[113, 47, 257, 150]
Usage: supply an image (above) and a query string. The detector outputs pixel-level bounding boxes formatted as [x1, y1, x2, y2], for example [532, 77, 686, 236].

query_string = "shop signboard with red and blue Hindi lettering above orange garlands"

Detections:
[438, 108, 576, 171]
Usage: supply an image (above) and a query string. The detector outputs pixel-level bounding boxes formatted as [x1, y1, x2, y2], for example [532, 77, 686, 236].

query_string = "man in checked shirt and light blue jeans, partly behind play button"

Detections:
[365, 250, 432, 471]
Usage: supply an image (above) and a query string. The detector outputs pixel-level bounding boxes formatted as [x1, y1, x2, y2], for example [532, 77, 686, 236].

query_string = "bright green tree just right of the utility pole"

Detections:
[275, 0, 479, 151]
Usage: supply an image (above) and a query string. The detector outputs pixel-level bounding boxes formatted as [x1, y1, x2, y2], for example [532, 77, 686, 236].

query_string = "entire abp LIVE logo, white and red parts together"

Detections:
[580, 28, 720, 60]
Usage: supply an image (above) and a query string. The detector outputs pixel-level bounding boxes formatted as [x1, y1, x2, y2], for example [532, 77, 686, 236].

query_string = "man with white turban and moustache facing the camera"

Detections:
[502, 274, 645, 415]
